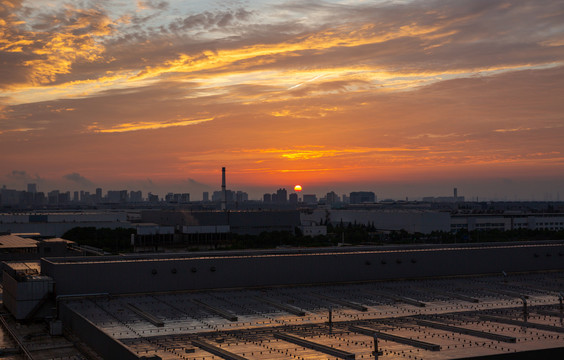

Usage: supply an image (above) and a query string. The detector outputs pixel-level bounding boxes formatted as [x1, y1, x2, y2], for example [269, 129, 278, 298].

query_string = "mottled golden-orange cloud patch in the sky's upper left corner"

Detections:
[0, 1, 115, 86]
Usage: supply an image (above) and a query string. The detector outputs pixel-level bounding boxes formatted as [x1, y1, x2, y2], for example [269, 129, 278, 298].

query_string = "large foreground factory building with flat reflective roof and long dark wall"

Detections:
[3, 241, 564, 360]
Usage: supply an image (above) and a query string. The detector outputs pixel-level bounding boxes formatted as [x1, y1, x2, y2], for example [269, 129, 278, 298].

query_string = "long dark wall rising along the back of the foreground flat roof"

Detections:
[41, 242, 564, 295]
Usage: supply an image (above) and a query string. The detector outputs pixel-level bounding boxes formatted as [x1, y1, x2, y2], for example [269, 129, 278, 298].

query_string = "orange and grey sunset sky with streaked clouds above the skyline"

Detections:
[0, 0, 564, 200]
